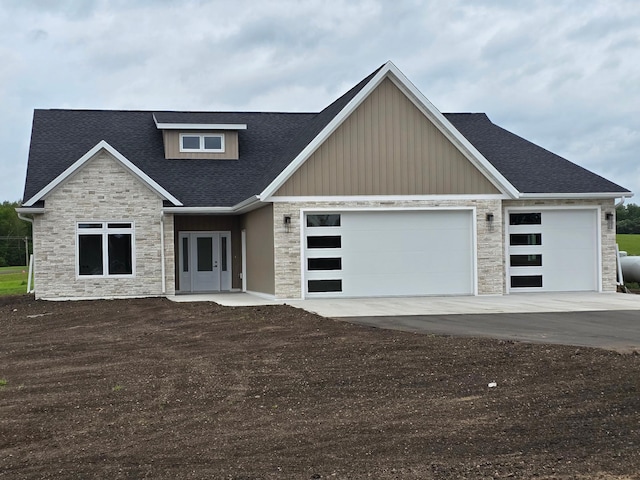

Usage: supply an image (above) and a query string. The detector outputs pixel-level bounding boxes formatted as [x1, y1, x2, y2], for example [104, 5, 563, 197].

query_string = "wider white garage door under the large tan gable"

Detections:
[304, 210, 474, 297]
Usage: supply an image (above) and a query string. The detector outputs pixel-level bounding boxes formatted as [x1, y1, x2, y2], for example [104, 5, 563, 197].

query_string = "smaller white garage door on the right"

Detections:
[507, 209, 599, 292]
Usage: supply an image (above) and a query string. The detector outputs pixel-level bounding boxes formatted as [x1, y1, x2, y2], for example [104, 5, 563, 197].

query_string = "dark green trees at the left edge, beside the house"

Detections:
[0, 201, 33, 267]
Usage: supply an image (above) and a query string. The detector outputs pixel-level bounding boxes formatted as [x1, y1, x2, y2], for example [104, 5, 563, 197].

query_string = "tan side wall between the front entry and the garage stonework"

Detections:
[240, 204, 275, 295]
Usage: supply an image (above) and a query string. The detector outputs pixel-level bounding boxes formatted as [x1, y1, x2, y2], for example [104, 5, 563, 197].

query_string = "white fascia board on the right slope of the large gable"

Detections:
[380, 62, 520, 198]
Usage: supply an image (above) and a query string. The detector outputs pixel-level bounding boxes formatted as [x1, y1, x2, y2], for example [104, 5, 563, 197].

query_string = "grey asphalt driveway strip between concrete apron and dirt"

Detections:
[340, 310, 640, 353]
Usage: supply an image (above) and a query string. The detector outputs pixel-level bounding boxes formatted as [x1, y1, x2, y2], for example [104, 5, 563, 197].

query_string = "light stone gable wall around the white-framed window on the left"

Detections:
[34, 151, 175, 299]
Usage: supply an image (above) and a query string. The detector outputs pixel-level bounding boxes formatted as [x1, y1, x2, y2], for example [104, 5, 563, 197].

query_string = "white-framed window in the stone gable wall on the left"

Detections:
[76, 221, 135, 277]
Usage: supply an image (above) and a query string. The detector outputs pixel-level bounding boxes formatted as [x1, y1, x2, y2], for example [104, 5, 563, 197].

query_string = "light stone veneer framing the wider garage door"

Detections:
[273, 200, 505, 298]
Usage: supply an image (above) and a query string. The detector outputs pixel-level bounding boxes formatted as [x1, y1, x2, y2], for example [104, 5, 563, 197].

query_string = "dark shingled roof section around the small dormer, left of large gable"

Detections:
[24, 110, 317, 207]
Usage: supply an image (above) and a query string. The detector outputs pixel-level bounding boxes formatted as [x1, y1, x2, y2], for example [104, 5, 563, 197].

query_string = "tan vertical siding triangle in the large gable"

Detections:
[276, 79, 500, 196]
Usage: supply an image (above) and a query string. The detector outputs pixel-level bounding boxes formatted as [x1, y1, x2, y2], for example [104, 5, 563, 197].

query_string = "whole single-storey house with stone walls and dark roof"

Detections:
[18, 62, 631, 299]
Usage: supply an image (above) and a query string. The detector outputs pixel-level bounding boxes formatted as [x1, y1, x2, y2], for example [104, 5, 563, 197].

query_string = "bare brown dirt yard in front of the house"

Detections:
[0, 297, 640, 479]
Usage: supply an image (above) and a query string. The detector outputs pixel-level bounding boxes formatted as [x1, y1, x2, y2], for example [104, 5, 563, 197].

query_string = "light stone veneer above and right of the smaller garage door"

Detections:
[503, 199, 617, 292]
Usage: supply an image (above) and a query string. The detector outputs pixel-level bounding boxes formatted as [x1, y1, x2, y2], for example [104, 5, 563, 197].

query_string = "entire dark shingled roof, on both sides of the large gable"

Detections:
[24, 67, 628, 207]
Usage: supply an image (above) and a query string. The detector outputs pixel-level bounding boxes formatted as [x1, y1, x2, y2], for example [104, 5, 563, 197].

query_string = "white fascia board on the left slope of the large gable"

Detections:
[259, 62, 393, 201]
